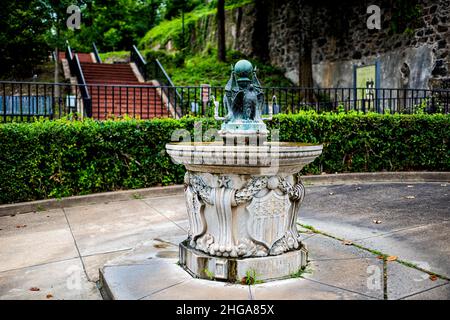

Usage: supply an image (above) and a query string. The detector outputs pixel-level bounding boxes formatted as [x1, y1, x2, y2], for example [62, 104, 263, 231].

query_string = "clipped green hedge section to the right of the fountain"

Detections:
[271, 112, 450, 174]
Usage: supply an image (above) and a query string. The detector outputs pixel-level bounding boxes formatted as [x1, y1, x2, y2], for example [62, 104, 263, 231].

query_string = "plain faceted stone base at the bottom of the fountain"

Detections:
[179, 241, 308, 283]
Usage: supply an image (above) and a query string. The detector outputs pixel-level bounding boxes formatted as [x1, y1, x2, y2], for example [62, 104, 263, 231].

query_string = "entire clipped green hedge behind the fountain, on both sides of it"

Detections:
[0, 112, 450, 203]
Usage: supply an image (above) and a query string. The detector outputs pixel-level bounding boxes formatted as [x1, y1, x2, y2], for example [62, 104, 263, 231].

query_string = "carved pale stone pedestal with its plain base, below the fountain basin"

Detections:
[180, 171, 307, 281]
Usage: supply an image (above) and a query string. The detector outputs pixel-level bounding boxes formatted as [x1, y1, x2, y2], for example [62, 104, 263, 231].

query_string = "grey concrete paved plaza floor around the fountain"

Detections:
[0, 183, 450, 299]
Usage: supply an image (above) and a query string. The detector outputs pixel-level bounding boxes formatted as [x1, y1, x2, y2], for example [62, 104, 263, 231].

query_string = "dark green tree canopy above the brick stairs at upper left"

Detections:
[0, 0, 167, 78]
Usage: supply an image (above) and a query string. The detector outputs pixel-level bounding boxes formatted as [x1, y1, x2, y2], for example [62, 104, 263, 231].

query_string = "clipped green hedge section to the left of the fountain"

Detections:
[0, 119, 186, 203]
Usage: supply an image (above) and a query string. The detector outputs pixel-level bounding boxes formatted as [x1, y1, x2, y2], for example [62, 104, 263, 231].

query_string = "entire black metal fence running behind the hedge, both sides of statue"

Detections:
[0, 82, 450, 122]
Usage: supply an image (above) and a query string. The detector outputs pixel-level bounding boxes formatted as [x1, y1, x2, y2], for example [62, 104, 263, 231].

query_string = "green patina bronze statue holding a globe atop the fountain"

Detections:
[216, 60, 272, 137]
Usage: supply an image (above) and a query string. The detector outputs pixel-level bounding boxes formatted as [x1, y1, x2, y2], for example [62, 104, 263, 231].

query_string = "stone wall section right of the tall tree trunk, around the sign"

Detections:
[306, 0, 450, 88]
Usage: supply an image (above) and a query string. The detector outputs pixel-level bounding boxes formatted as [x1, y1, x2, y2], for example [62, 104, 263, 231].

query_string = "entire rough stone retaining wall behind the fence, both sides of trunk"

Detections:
[191, 0, 450, 88]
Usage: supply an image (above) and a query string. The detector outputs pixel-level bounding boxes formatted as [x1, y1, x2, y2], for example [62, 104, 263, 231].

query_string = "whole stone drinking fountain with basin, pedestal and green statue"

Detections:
[166, 60, 322, 282]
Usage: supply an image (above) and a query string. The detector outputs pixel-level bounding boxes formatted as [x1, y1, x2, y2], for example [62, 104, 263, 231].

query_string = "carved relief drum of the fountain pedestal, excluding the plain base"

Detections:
[185, 172, 305, 257]
